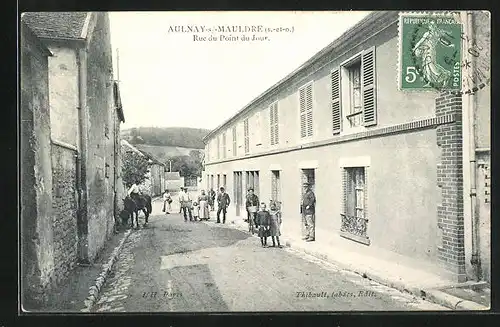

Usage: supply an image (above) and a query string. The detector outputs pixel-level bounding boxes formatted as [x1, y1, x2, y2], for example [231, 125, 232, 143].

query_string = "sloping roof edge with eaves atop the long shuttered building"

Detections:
[203, 11, 399, 142]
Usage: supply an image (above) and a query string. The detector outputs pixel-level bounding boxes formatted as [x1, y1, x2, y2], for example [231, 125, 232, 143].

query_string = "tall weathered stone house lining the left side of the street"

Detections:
[21, 12, 124, 310]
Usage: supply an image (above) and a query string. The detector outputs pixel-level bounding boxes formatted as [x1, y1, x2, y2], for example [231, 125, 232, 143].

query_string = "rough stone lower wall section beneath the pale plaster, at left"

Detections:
[52, 144, 78, 283]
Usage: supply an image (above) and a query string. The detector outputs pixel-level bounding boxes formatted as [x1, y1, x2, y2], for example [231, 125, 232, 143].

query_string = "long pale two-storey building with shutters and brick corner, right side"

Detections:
[203, 12, 490, 281]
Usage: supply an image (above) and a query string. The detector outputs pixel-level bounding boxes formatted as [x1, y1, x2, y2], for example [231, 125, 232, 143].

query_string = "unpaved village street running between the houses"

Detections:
[94, 201, 445, 312]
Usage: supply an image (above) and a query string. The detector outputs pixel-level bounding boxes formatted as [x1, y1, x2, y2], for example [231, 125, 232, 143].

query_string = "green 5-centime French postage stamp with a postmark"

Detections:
[398, 13, 462, 92]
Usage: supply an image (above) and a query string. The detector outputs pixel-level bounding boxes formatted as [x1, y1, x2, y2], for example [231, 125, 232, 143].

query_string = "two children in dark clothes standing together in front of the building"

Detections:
[255, 201, 282, 248]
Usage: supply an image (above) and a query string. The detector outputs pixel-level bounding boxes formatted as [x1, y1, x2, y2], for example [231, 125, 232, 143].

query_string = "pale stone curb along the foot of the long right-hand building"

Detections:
[227, 222, 490, 311]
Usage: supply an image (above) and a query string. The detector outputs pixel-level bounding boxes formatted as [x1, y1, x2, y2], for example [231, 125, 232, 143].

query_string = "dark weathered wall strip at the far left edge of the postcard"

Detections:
[20, 24, 54, 310]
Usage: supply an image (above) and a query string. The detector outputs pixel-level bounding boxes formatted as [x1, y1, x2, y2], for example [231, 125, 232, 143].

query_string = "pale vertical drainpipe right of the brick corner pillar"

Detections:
[465, 11, 481, 281]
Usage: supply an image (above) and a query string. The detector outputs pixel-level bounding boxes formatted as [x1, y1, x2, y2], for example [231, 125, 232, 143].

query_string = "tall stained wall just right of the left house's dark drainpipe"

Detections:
[87, 12, 115, 261]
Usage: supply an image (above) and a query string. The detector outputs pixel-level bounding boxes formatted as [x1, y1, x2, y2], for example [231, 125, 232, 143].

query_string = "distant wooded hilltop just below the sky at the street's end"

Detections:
[122, 127, 210, 149]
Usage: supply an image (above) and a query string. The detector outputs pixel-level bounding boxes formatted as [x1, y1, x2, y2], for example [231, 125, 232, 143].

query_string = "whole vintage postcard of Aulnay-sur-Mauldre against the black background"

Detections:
[19, 10, 491, 314]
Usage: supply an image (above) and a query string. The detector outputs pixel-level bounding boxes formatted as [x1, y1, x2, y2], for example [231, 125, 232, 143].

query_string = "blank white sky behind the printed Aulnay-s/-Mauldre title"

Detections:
[109, 11, 369, 129]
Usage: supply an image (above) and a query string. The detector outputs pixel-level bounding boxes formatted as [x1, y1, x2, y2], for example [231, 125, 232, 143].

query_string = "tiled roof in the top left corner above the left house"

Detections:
[21, 12, 90, 40]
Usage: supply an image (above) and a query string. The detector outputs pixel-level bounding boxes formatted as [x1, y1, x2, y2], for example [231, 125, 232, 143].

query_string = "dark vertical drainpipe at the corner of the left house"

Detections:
[77, 47, 89, 264]
